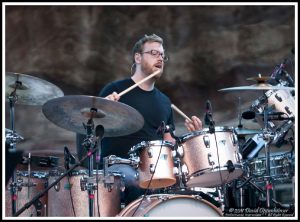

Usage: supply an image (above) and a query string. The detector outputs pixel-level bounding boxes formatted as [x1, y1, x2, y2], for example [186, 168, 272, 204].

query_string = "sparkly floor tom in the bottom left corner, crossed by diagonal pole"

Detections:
[5, 171, 48, 217]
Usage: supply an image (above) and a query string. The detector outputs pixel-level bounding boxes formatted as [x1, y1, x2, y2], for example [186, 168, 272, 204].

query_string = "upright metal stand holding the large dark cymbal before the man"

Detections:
[80, 115, 97, 217]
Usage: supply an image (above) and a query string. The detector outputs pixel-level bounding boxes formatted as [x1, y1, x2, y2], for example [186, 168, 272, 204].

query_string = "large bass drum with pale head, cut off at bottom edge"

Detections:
[117, 194, 222, 217]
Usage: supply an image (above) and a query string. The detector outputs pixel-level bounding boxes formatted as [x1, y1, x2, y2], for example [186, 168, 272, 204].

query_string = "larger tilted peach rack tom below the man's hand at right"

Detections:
[177, 127, 243, 187]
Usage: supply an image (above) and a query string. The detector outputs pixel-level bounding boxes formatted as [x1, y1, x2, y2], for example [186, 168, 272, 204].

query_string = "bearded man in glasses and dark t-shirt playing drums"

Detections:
[77, 34, 202, 205]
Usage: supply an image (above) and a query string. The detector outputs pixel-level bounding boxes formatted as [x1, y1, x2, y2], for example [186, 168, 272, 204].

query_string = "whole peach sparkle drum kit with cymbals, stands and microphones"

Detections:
[5, 67, 295, 217]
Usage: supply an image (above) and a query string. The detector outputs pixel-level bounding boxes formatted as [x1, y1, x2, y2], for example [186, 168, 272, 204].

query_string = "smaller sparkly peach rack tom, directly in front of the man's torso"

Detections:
[130, 140, 176, 189]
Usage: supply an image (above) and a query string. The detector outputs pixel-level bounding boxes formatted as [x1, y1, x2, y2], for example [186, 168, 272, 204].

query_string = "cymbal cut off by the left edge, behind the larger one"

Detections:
[5, 72, 64, 106]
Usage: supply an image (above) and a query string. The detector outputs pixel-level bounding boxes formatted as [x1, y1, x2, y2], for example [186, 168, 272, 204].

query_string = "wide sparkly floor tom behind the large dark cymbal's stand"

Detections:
[48, 170, 122, 217]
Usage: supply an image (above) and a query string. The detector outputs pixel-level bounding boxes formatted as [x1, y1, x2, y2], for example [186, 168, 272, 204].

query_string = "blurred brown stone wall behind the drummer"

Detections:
[3, 5, 295, 158]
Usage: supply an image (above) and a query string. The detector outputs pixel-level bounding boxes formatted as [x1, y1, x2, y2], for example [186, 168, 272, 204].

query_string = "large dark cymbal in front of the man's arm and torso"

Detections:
[42, 95, 144, 137]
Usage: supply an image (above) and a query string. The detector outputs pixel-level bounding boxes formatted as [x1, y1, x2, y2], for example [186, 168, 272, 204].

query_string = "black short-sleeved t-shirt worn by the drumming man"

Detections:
[99, 78, 175, 158]
